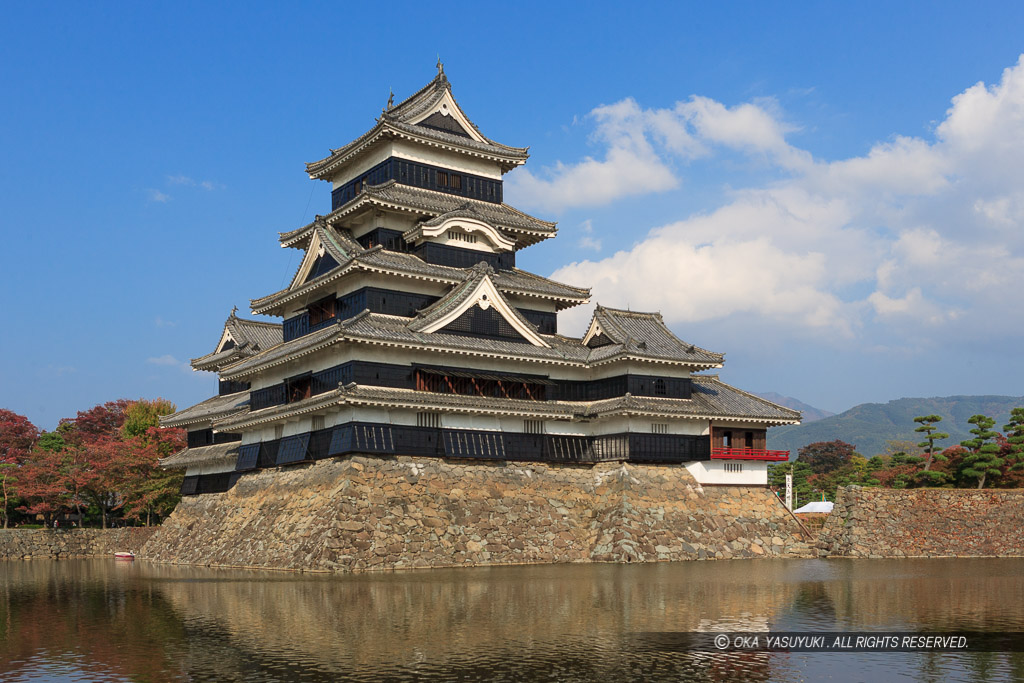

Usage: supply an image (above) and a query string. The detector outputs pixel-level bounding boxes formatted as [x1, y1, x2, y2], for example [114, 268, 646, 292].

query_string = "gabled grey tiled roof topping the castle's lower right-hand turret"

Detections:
[590, 305, 725, 367]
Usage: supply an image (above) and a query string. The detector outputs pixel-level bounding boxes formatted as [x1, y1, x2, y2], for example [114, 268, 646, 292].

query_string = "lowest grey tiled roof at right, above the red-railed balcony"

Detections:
[587, 375, 800, 424]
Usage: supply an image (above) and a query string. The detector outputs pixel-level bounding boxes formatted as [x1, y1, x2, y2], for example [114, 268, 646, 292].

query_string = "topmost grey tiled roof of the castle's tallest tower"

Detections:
[306, 73, 529, 178]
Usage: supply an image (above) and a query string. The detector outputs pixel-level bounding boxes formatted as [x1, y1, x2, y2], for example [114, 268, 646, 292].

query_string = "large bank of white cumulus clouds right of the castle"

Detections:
[552, 55, 1024, 347]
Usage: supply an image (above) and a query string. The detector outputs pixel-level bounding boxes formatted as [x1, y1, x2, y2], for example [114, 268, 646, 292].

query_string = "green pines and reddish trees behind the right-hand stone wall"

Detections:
[768, 408, 1024, 502]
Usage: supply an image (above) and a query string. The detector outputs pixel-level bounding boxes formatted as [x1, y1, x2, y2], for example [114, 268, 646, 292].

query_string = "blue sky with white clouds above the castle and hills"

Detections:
[0, 2, 1024, 429]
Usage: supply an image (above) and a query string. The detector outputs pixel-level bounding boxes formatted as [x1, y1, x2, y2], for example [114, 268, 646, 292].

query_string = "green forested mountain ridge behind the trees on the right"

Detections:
[766, 396, 1024, 459]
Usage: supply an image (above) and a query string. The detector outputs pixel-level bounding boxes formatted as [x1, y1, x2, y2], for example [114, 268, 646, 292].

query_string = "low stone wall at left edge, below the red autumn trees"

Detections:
[0, 526, 158, 560]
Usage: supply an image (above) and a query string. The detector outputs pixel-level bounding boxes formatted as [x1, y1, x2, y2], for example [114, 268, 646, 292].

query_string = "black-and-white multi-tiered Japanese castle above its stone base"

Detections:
[162, 63, 800, 495]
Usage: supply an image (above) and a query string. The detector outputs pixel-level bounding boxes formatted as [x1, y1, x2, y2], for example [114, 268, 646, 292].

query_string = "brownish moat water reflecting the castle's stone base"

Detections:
[0, 559, 1024, 683]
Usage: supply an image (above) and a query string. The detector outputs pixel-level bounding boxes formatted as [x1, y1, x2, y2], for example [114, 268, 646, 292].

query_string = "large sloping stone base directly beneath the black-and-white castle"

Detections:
[142, 456, 811, 571]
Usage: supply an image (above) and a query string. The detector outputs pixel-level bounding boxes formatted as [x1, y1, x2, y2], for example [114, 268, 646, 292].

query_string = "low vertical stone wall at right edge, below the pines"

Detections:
[818, 486, 1024, 557]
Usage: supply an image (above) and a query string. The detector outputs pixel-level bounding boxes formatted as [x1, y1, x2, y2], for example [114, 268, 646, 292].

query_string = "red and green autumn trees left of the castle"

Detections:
[0, 398, 186, 528]
